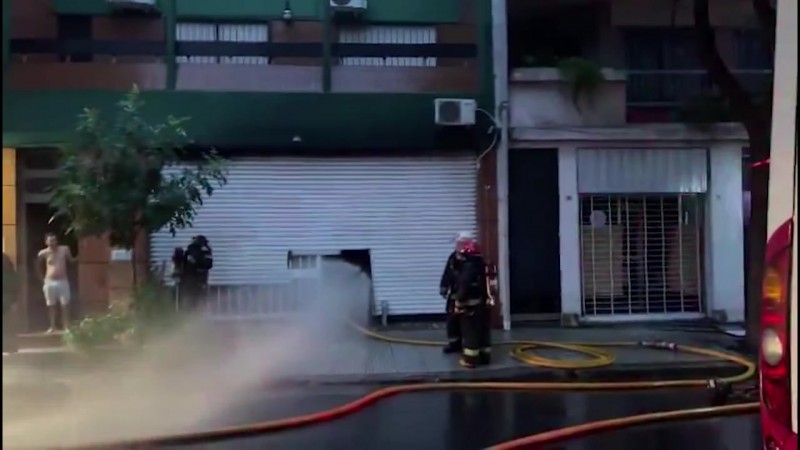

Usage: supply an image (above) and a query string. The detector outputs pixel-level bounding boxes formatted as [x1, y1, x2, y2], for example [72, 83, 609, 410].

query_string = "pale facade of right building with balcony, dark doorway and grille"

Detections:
[494, 0, 771, 326]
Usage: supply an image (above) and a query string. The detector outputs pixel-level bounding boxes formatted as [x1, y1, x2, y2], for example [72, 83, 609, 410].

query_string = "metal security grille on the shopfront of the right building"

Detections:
[580, 194, 703, 316]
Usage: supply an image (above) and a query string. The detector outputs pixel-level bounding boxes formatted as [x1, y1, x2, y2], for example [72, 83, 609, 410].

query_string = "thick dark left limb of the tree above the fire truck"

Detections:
[694, 0, 769, 158]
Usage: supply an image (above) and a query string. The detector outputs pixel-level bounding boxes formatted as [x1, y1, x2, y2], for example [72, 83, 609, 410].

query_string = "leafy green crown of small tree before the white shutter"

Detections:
[51, 86, 226, 249]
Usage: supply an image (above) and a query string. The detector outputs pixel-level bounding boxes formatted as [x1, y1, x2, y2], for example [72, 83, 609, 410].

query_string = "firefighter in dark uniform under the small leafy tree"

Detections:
[173, 235, 214, 309]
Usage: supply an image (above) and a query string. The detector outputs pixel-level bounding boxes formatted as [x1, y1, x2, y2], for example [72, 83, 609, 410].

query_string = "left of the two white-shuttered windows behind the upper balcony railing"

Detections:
[175, 22, 269, 65]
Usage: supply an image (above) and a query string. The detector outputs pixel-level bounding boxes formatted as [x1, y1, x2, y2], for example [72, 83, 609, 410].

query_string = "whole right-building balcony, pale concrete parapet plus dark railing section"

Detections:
[509, 68, 772, 128]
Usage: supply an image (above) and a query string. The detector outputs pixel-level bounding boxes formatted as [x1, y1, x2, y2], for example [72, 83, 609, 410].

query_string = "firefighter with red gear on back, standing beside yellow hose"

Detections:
[455, 239, 494, 368]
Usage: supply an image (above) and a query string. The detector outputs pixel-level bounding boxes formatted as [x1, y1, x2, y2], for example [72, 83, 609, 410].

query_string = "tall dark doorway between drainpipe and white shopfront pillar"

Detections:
[508, 149, 561, 314]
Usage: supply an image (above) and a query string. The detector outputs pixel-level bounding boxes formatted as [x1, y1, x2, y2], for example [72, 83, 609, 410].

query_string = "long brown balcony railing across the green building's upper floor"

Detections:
[7, 39, 478, 92]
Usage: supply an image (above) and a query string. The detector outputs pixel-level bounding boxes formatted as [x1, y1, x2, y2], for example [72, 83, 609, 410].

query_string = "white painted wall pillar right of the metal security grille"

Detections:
[705, 143, 744, 322]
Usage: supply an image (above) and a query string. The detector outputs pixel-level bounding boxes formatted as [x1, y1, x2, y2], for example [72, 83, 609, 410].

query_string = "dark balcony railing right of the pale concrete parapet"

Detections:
[626, 69, 772, 122]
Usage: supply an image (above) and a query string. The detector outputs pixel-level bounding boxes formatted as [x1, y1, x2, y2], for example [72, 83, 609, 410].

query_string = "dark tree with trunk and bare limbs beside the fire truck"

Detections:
[693, 0, 776, 349]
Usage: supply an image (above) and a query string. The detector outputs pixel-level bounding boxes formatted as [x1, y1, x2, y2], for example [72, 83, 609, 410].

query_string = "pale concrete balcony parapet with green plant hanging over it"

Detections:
[509, 68, 626, 128]
